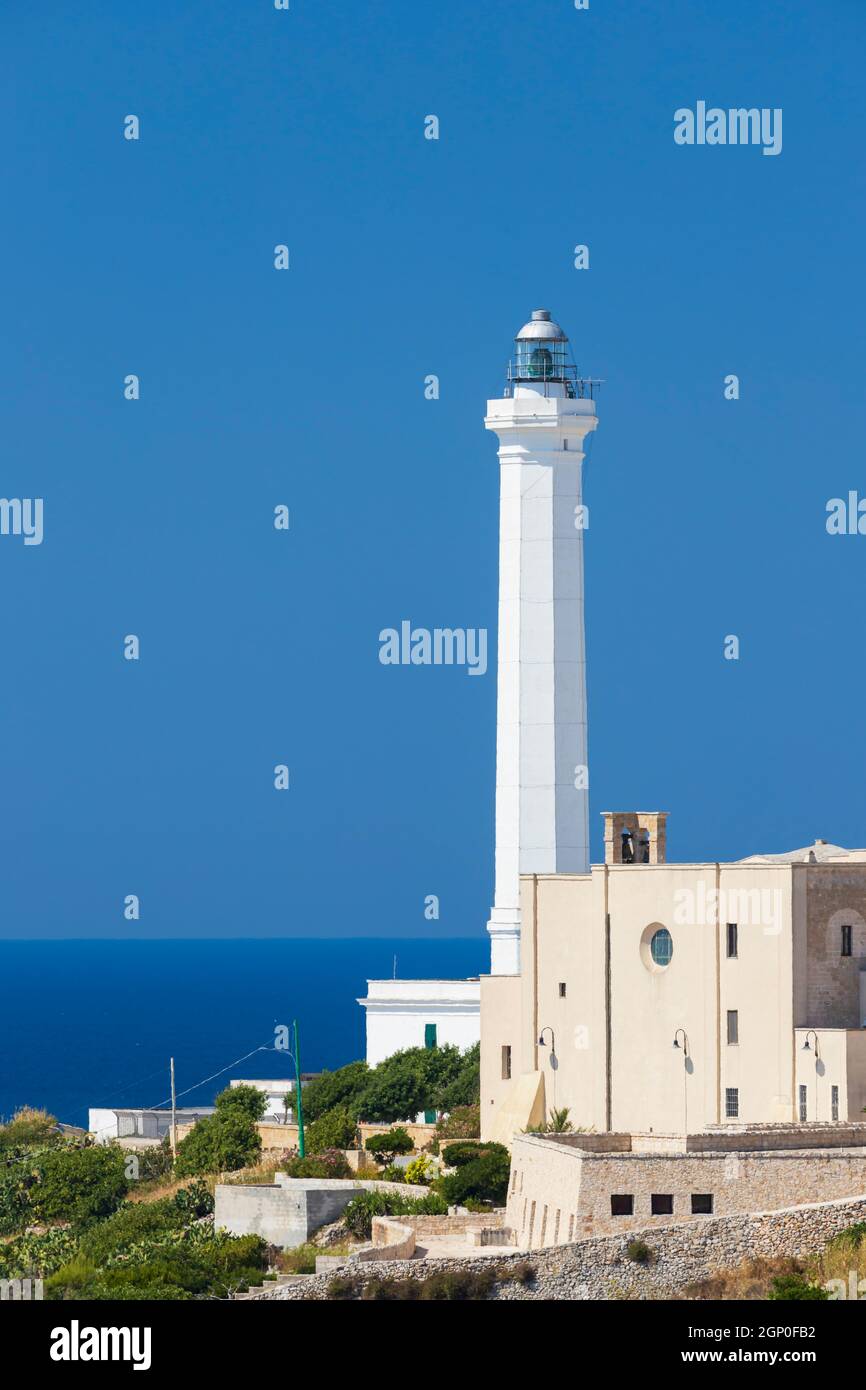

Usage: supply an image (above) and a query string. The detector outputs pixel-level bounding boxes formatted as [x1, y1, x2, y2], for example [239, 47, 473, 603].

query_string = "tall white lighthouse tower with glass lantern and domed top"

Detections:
[484, 309, 598, 974]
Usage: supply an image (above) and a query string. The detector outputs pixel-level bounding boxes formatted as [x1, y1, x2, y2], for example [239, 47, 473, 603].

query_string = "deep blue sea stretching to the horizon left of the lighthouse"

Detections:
[0, 934, 489, 1126]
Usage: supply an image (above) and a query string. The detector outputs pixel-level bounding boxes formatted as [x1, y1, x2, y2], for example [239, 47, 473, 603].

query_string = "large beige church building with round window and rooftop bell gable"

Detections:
[481, 812, 866, 1141]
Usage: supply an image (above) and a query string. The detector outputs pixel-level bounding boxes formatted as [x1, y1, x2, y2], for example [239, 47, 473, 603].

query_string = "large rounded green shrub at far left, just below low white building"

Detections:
[29, 1144, 129, 1226]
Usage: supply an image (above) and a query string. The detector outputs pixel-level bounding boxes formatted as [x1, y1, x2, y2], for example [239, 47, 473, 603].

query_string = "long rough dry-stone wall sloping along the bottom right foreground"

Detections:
[250, 1197, 866, 1301]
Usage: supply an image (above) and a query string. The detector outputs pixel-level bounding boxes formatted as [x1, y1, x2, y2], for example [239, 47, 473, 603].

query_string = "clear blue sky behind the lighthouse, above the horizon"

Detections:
[0, 0, 866, 940]
